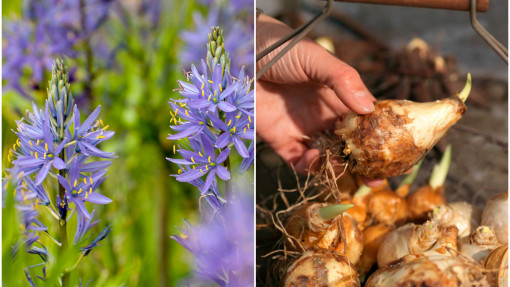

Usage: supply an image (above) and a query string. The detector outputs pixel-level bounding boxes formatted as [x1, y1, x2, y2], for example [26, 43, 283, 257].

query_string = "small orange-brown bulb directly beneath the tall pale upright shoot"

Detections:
[406, 185, 446, 223]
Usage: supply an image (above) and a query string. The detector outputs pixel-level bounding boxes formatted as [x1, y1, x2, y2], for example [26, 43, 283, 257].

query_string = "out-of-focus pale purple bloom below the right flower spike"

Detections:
[172, 195, 255, 286]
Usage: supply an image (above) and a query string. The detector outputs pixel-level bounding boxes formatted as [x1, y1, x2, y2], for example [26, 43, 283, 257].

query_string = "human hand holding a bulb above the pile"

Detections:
[256, 15, 381, 186]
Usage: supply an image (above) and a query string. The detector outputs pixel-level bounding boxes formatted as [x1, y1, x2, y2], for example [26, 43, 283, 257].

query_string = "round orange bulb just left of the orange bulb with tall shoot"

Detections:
[367, 190, 408, 226]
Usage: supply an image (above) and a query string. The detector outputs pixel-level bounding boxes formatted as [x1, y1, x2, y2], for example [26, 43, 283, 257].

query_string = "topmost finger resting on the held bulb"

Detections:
[303, 43, 375, 114]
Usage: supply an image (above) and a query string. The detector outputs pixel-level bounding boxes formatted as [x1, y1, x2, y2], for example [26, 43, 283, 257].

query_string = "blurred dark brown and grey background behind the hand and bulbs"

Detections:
[256, 0, 508, 286]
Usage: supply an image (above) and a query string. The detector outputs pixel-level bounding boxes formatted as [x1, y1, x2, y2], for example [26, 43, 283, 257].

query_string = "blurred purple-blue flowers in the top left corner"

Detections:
[2, 0, 114, 98]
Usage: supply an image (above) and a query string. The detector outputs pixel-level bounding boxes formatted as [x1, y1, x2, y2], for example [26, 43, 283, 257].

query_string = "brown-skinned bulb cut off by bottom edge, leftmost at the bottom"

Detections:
[281, 250, 360, 287]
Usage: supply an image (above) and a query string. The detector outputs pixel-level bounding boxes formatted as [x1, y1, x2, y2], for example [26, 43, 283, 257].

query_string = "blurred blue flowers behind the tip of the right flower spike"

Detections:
[180, 0, 254, 77]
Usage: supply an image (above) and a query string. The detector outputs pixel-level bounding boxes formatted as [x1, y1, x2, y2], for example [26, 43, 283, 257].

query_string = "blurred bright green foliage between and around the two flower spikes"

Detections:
[2, 0, 223, 286]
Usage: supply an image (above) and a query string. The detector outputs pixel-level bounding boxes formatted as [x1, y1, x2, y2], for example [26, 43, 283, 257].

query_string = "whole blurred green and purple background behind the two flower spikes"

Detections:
[2, 0, 254, 286]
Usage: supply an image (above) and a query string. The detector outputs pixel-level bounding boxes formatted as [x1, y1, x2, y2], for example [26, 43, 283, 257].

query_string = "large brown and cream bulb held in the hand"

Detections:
[335, 97, 466, 179]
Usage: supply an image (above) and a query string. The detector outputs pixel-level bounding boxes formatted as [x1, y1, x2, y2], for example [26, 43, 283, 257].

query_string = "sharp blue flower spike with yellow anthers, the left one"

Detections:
[3, 60, 115, 285]
